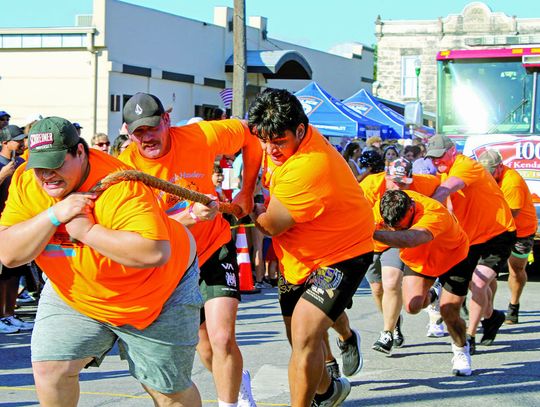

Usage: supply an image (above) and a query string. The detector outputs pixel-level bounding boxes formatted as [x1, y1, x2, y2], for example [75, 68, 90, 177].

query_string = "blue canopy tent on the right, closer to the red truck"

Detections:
[343, 89, 435, 138]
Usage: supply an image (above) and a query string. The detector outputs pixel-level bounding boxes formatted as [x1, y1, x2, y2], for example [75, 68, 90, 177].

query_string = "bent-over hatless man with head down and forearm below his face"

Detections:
[373, 190, 472, 376]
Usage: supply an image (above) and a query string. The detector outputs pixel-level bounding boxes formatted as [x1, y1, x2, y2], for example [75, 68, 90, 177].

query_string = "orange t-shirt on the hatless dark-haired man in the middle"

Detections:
[266, 126, 374, 284]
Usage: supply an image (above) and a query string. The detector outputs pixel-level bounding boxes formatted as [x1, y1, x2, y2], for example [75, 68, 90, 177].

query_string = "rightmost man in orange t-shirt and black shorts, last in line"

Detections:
[478, 150, 538, 324]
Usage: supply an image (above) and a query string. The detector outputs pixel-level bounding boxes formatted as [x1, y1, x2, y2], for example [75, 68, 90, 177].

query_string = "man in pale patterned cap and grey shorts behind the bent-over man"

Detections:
[360, 158, 440, 354]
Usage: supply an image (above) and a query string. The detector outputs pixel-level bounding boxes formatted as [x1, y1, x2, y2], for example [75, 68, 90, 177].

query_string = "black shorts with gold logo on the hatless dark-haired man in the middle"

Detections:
[278, 252, 373, 321]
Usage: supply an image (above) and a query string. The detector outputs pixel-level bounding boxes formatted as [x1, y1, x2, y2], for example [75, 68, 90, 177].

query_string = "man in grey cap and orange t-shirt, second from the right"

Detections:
[426, 134, 516, 360]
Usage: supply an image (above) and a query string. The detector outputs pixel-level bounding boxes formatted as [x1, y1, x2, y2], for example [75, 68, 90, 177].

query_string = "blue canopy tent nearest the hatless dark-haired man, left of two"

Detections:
[295, 82, 388, 138]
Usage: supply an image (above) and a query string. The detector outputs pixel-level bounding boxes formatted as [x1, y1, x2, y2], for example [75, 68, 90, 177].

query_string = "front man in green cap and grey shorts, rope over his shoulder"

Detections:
[0, 117, 202, 406]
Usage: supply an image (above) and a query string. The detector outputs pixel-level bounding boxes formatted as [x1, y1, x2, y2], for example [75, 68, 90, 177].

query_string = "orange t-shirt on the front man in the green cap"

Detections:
[0, 150, 194, 329]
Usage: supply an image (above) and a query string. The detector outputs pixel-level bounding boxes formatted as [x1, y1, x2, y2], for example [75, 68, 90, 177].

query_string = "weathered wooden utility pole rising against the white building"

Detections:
[232, 0, 247, 119]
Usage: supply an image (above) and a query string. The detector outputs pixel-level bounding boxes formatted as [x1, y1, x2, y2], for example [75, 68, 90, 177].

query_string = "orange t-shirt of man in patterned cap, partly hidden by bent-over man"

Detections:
[360, 172, 441, 253]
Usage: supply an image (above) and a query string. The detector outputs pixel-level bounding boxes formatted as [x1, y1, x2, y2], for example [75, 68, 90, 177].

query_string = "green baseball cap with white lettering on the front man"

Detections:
[26, 117, 80, 170]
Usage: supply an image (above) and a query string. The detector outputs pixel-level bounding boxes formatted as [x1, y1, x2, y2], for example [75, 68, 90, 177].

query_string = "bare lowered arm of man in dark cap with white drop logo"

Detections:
[233, 122, 262, 216]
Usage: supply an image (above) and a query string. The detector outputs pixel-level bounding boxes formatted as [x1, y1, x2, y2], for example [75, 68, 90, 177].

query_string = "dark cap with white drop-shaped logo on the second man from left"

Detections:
[123, 92, 165, 134]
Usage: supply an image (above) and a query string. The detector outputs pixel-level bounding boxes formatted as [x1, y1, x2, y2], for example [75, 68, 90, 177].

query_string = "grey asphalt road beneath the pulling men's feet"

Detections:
[0, 272, 540, 407]
